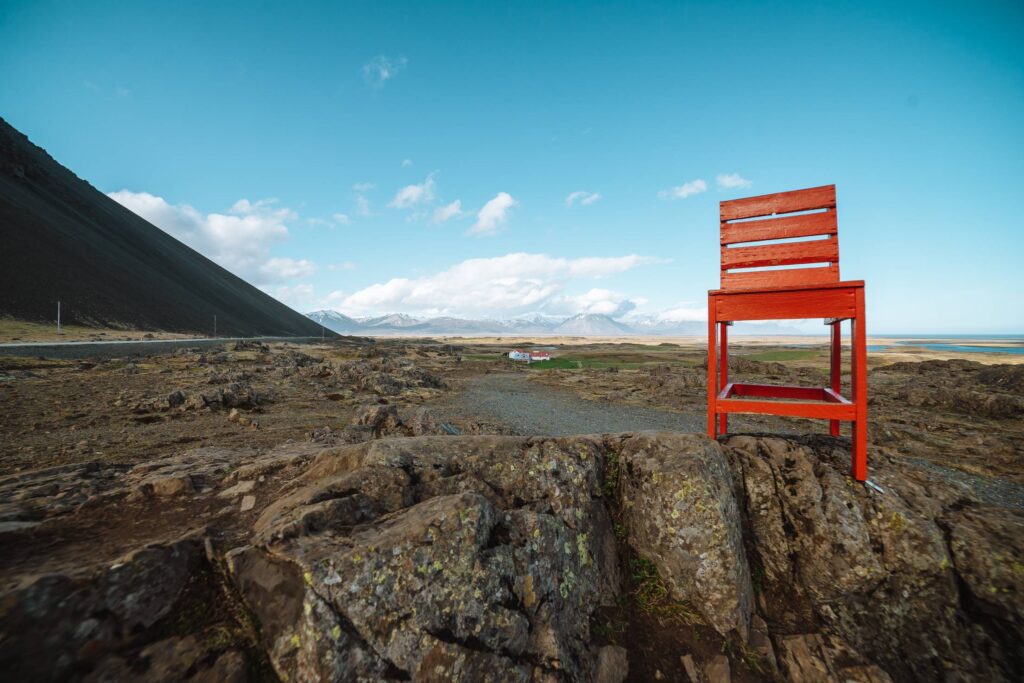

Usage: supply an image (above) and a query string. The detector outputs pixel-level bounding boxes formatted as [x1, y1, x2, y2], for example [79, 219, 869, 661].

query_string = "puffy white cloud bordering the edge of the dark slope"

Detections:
[108, 189, 307, 285]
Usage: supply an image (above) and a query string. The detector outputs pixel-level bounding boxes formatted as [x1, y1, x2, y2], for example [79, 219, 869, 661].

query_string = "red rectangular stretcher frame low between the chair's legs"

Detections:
[716, 382, 856, 420]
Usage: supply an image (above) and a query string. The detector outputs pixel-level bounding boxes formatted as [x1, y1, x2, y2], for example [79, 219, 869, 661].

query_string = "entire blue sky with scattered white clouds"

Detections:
[0, 0, 1024, 334]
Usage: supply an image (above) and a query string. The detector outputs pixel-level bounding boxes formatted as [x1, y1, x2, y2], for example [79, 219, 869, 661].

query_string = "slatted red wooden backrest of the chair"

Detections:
[720, 185, 839, 290]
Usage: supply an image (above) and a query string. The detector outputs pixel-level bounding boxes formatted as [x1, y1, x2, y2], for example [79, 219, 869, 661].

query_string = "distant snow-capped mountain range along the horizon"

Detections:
[306, 310, 805, 337]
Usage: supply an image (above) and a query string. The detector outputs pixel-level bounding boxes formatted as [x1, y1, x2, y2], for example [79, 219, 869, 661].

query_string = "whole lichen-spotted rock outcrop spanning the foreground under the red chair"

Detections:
[0, 430, 1024, 682]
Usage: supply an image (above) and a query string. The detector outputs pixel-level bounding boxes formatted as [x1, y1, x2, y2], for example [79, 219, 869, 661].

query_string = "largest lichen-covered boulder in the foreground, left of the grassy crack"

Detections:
[229, 436, 617, 680]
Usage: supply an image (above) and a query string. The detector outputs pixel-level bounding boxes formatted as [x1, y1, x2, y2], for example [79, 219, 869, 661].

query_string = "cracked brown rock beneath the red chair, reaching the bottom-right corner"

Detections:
[725, 436, 1024, 680]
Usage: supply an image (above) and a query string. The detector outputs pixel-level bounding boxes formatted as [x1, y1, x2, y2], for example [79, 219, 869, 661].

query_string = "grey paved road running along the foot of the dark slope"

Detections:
[0, 337, 331, 358]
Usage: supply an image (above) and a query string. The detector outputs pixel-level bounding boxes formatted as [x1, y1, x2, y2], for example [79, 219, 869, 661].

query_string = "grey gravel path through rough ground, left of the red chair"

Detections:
[451, 373, 705, 436]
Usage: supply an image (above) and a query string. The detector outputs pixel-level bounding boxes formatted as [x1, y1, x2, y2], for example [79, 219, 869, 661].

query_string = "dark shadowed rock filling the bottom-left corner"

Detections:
[0, 539, 248, 681]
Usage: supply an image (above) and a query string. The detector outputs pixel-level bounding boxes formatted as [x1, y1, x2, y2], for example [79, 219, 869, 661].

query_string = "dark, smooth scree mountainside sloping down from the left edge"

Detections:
[0, 119, 332, 337]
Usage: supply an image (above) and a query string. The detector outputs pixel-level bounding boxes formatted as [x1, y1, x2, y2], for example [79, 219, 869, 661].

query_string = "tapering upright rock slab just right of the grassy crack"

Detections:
[618, 433, 753, 639]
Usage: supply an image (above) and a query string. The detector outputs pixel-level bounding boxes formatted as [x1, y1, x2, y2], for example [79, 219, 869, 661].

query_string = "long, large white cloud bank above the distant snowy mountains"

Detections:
[338, 253, 658, 315]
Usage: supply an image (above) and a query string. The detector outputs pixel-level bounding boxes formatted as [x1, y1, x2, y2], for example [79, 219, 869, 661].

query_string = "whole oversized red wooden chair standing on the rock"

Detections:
[708, 185, 867, 481]
